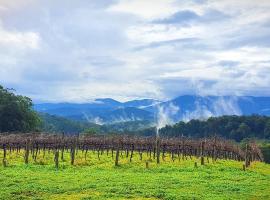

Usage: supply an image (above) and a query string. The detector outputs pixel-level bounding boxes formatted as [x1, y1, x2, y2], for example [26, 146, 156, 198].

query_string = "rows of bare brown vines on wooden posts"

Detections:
[0, 134, 263, 170]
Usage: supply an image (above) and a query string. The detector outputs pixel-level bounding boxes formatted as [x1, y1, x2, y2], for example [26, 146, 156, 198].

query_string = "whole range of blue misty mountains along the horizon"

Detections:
[34, 95, 270, 124]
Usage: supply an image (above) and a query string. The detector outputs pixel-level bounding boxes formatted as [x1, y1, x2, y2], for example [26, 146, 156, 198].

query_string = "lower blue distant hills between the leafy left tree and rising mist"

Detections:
[34, 99, 156, 124]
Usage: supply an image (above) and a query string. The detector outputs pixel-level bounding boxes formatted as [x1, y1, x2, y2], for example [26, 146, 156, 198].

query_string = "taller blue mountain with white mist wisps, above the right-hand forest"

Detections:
[149, 95, 270, 122]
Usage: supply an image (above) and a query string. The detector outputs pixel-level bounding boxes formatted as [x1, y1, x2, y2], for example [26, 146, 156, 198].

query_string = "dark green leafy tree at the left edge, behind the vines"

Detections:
[0, 85, 40, 132]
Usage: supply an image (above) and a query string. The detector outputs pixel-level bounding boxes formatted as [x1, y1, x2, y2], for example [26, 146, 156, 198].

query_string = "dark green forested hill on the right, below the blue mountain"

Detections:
[160, 115, 270, 141]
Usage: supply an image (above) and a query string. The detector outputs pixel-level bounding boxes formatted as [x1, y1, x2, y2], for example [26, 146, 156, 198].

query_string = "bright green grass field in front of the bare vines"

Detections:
[0, 152, 270, 200]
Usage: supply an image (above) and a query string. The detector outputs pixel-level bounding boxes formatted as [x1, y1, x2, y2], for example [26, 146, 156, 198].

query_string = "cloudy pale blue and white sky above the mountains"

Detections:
[0, 0, 270, 102]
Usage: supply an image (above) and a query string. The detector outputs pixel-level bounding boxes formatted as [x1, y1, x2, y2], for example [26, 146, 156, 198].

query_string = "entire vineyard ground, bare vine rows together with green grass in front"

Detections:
[0, 134, 270, 200]
